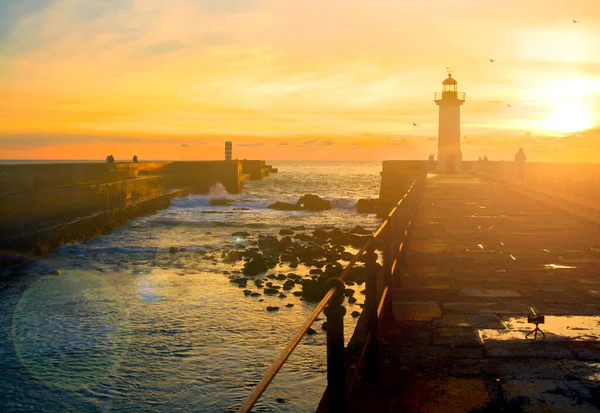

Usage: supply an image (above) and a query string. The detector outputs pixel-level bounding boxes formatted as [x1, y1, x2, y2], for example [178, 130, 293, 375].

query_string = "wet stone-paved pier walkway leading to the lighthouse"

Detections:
[350, 174, 600, 413]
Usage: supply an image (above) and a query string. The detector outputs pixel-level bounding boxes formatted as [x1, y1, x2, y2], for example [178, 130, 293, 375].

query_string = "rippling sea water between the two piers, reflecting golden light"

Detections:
[0, 162, 381, 412]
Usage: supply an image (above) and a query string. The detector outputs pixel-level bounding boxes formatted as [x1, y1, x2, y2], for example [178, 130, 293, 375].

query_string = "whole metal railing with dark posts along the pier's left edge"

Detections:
[238, 174, 425, 413]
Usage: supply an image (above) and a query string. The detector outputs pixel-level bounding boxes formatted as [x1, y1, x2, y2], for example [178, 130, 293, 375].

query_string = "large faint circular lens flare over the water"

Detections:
[12, 271, 129, 390]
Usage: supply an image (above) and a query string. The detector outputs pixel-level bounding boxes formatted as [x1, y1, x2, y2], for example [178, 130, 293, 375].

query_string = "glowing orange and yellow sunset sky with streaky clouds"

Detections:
[0, 0, 600, 162]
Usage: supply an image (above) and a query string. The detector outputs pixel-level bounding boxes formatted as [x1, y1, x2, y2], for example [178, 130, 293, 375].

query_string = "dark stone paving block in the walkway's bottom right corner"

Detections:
[502, 380, 600, 413]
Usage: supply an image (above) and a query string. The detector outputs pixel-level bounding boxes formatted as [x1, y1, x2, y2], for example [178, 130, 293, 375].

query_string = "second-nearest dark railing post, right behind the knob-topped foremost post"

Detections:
[365, 246, 381, 383]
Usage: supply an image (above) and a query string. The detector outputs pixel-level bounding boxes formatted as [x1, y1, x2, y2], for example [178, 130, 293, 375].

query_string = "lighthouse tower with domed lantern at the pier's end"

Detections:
[434, 73, 465, 172]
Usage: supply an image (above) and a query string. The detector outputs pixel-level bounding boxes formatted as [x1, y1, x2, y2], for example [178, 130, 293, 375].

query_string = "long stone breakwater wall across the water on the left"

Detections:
[0, 161, 264, 252]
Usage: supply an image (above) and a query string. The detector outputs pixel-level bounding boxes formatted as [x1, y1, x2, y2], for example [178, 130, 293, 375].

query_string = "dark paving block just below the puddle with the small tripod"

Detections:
[483, 340, 575, 360]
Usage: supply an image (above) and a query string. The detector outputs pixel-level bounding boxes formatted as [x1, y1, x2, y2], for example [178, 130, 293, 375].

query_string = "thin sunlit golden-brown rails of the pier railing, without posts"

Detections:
[238, 172, 420, 413]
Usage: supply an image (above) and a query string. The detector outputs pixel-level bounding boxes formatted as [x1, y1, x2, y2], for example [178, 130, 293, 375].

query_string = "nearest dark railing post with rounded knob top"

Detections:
[324, 277, 346, 413]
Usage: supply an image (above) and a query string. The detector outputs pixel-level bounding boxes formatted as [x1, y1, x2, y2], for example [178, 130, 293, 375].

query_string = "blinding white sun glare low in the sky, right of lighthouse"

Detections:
[540, 100, 594, 133]
